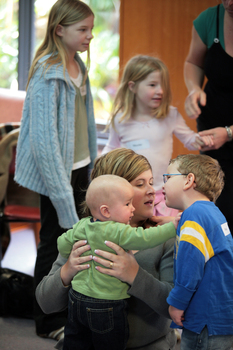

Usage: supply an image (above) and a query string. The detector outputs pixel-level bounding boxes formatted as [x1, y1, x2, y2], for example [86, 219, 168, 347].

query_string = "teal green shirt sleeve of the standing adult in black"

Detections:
[193, 4, 225, 50]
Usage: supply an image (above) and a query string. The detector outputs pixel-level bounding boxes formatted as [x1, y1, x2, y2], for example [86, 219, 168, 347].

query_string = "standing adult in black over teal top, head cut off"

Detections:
[184, 0, 233, 233]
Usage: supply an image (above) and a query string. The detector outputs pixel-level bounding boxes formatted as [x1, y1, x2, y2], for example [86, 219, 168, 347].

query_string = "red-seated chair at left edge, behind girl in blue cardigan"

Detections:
[0, 123, 40, 263]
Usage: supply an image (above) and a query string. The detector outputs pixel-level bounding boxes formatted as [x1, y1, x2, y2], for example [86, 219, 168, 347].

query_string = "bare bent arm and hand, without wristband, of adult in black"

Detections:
[184, 26, 207, 119]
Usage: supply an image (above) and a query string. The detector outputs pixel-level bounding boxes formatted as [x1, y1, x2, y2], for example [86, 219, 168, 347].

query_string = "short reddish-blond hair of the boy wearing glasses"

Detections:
[170, 154, 224, 203]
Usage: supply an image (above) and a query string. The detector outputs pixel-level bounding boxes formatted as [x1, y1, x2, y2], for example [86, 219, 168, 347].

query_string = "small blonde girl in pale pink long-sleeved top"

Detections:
[103, 55, 211, 216]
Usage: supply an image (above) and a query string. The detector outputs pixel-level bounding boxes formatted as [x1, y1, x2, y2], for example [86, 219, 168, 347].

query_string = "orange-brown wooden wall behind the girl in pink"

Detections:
[120, 0, 221, 156]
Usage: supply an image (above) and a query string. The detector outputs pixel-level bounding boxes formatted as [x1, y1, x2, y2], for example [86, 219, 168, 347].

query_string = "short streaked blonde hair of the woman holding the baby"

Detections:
[82, 148, 152, 216]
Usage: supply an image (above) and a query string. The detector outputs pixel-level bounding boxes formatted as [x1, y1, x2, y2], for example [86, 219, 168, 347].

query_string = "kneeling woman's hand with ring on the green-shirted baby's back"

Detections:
[93, 241, 139, 285]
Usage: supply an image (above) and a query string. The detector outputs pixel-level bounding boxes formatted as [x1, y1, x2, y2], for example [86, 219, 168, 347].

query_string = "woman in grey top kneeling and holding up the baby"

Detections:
[36, 148, 176, 350]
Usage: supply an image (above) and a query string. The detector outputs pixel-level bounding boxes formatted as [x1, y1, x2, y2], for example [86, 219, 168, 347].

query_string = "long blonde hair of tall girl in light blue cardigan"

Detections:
[27, 0, 94, 88]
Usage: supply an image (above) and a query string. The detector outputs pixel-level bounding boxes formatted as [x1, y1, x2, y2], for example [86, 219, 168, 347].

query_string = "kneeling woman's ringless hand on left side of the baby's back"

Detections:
[61, 240, 92, 286]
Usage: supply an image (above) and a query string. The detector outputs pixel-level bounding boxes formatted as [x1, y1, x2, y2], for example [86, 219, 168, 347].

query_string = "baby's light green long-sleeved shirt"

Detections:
[58, 217, 176, 300]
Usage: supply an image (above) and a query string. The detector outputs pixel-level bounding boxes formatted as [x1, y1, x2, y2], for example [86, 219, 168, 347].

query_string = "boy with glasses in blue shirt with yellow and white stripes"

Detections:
[163, 154, 233, 350]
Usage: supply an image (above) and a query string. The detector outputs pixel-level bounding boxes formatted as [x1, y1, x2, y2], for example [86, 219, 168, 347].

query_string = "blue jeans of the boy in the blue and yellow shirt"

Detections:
[180, 327, 233, 350]
